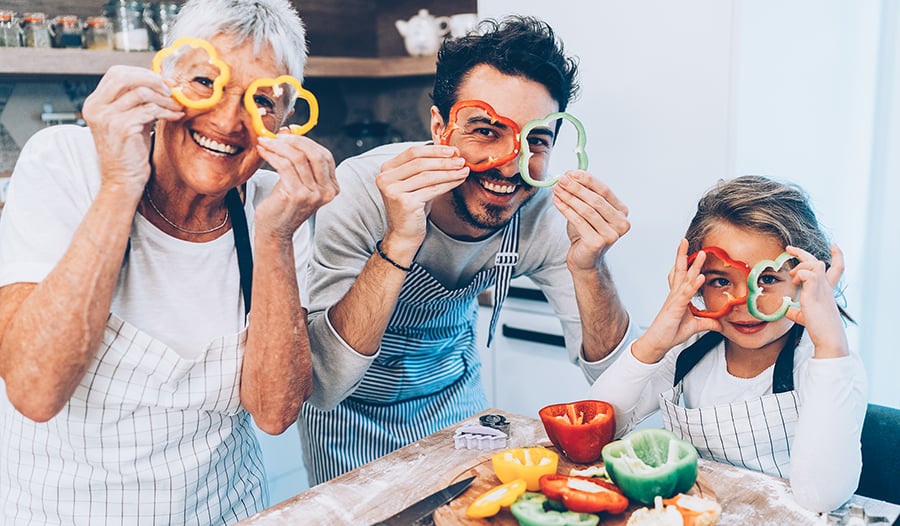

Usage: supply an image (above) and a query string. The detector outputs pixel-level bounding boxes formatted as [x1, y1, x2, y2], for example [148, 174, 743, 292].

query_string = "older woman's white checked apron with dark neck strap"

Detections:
[0, 188, 269, 526]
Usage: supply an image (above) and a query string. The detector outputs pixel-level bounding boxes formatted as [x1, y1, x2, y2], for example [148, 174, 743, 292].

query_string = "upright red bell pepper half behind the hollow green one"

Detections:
[538, 400, 616, 464]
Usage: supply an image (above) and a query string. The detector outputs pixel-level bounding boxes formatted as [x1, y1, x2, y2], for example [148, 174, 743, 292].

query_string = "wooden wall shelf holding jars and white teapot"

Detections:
[0, 48, 435, 78]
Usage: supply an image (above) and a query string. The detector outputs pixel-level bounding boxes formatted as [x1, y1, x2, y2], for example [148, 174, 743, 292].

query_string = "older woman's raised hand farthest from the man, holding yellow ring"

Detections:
[83, 66, 184, 196]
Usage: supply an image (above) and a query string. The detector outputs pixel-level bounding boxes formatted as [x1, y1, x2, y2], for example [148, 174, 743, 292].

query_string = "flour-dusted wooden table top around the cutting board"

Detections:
[240, 409, 900, 526]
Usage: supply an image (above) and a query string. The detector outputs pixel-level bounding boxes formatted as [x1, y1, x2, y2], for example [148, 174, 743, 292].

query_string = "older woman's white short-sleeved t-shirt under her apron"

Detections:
[0, 126, 310, 358]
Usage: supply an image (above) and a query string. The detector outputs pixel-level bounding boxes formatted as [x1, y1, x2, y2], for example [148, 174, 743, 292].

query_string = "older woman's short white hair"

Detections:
[166, 0, 307, 82]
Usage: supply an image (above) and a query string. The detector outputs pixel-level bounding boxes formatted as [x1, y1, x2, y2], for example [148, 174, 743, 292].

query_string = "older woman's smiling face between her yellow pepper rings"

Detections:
[156, 35, 286, 198]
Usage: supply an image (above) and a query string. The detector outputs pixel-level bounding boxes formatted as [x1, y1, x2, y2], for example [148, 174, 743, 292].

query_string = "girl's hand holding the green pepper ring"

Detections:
[785, 245, 849, 358]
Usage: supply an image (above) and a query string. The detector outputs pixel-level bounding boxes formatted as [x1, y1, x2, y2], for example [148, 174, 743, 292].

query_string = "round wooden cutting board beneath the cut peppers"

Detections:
[433, 445, 716, 526]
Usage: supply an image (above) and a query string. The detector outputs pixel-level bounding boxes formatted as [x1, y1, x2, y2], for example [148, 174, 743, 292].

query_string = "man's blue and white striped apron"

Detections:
[300, 213, 519, 484]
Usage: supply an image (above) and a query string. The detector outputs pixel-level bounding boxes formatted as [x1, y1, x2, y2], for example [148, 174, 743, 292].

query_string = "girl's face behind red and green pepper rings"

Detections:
[700, 222, 796, 351]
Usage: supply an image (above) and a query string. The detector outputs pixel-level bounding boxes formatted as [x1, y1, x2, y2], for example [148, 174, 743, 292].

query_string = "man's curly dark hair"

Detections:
[431, 16, 578, 119]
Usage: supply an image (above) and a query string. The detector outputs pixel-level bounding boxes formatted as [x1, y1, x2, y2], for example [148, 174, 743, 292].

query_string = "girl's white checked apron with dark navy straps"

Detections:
[659, 324, 803, 478]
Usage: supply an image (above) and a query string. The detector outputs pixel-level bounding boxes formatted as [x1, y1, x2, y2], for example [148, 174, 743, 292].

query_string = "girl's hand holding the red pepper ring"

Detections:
[631, 239, 722, 363]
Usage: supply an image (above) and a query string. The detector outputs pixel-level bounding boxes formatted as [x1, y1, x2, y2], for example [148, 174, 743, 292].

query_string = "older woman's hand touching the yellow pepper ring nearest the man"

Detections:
[256, 132, 340, 239]
